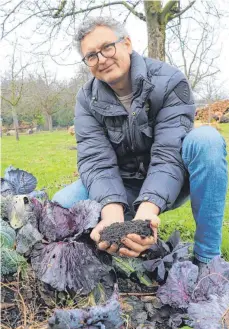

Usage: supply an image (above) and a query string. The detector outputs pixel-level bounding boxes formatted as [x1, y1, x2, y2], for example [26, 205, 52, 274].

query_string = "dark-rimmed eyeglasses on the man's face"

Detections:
[82, 37, 124, 67]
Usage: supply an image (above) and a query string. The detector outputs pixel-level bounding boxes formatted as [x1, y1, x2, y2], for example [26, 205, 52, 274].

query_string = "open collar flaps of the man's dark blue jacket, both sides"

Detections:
[92, 51, 153, 115]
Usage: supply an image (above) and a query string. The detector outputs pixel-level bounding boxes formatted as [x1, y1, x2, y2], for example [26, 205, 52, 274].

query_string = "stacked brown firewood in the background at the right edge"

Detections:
[196, 100, 229, 123]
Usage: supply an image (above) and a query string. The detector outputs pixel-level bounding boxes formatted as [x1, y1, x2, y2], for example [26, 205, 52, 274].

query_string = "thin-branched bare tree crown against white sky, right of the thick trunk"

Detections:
[166, 6, 221, 90]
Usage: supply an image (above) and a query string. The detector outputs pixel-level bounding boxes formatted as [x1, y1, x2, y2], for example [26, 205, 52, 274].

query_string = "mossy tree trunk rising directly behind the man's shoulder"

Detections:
[144, 1, 166, 61]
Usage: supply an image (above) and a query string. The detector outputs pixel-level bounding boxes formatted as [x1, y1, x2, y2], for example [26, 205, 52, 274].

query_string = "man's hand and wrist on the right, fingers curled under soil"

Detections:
[119, 202, 160, 257]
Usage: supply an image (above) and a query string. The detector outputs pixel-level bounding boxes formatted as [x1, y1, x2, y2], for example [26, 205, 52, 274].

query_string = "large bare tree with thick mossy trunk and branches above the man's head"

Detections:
[0, 0, 200, 60]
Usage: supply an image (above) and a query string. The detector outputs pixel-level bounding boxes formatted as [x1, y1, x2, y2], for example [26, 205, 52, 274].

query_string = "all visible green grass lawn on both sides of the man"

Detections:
[1, 124, 229, 261]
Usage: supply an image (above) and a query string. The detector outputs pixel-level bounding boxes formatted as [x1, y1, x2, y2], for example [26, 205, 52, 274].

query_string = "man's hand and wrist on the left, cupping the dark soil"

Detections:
[90, 203, 124, 254]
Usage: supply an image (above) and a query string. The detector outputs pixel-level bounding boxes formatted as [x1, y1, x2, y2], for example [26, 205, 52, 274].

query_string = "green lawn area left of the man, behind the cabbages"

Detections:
[1, 131, 77, 198]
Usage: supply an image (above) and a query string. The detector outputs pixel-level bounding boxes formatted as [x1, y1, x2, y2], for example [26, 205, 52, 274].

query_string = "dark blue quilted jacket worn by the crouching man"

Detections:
[75, 52, 195, 212]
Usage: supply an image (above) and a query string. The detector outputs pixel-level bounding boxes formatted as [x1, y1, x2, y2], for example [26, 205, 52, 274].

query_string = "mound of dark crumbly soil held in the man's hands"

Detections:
[100, 220, 153, 248]
